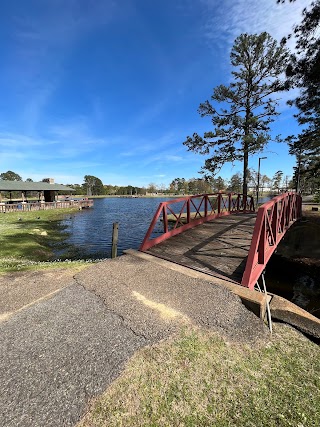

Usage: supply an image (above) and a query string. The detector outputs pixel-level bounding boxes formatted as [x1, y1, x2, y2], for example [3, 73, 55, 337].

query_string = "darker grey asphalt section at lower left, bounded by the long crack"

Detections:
[0, 280, 146, 427]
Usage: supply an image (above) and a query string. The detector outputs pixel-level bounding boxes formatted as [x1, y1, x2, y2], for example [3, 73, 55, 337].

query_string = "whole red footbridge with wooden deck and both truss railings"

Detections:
[140, 192, 302, 289]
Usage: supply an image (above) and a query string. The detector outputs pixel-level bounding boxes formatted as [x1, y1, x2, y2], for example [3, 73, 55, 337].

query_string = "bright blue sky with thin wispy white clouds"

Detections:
[0, 0, 311, 186]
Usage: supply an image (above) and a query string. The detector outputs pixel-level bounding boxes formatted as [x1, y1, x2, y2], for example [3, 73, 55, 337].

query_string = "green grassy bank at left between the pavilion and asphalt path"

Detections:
[0, 208, 92, 273]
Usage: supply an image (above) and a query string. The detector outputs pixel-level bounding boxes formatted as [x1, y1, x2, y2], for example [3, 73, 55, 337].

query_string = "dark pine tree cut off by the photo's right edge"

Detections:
[286, 0, 320, 191]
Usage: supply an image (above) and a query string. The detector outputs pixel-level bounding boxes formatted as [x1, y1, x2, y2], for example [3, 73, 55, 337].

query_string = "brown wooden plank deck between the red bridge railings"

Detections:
[147, 213, 256, 283]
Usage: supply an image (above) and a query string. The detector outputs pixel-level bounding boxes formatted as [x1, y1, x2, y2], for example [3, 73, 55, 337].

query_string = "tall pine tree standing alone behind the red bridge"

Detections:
[184, 32, 288, 194]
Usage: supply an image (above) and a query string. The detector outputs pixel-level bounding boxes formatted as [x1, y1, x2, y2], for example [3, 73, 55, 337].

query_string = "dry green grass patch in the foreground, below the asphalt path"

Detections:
[78, 325, 320, 427]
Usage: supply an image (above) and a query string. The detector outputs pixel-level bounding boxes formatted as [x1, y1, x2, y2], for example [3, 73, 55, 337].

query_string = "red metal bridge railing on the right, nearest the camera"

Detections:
[241, 193, 302, 289]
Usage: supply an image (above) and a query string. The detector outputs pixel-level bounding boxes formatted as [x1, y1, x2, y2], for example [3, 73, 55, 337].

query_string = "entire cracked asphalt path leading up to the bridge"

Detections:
[0, 255, 268, 427]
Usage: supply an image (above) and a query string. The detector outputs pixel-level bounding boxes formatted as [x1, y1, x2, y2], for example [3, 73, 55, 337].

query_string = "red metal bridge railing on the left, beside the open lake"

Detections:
[139, 193, 254, 251]
